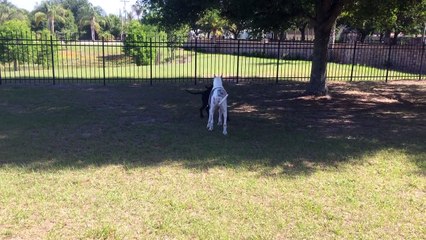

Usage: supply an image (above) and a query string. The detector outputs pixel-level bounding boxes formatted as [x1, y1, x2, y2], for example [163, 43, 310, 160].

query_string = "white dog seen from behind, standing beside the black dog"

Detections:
[207, 76, 228, 135]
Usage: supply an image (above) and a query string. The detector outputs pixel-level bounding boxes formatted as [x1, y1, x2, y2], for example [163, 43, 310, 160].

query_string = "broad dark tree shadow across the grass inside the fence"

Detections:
[0, 82, 426, 176]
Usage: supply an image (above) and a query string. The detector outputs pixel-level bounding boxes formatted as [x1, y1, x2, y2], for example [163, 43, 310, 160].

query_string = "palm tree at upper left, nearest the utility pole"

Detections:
[79, 4, 104, 41]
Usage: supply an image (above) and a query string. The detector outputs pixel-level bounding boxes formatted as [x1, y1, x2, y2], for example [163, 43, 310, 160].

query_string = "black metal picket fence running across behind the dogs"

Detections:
[0, 32, 426, 85]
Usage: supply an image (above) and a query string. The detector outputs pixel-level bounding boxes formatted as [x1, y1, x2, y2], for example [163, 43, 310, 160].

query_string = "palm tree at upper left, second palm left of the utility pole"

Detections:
[34, 1, 66, 34]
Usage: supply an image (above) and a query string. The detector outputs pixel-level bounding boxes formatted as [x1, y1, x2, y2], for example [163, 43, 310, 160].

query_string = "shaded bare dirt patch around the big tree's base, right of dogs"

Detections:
[225, 81, 426, 141]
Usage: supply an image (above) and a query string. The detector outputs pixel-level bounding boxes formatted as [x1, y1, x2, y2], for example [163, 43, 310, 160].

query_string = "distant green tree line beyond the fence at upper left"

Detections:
[0, 0, 123, 40]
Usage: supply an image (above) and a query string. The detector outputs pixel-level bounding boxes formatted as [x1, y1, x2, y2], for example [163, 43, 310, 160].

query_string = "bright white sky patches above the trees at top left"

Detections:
[9, 0, 136, 15]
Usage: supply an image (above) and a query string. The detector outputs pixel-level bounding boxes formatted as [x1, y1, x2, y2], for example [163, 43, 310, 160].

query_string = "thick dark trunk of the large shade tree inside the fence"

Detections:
[306, 0, 345, 96]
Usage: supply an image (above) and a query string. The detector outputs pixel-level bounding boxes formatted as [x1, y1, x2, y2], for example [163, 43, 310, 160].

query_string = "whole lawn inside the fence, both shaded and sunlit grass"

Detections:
[0, 82, 426, 239]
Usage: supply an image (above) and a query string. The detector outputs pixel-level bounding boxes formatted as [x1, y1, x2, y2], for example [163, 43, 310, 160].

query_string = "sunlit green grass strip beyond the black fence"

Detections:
[2, 45, 419, 81]
